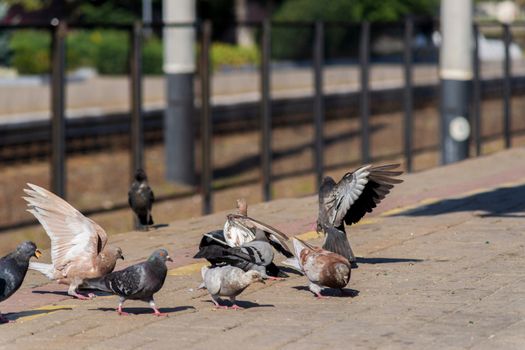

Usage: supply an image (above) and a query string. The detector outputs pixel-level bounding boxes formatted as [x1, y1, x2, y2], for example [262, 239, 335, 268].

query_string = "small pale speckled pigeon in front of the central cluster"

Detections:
[201, 265, 264, 310]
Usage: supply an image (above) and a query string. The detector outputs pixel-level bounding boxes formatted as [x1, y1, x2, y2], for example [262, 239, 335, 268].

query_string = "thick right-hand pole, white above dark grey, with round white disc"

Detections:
[439, 0, 472, 164]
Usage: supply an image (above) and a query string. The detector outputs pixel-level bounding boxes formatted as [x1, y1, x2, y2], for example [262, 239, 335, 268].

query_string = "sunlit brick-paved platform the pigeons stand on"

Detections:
[0, 148, 525, 350]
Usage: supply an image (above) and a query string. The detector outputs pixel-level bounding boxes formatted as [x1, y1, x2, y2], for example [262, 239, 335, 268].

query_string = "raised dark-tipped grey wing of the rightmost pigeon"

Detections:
[323, 164, 403, 227]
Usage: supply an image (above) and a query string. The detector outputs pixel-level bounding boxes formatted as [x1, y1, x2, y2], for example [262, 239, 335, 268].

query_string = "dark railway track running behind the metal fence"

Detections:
[0, 75, 525, 164]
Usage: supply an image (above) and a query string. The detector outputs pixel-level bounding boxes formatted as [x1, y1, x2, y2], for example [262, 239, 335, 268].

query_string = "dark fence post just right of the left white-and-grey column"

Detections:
[200, 20, 213, 215]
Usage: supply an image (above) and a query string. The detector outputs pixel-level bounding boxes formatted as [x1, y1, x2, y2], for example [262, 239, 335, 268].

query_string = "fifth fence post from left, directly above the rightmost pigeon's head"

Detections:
[313, 21, 324, 188]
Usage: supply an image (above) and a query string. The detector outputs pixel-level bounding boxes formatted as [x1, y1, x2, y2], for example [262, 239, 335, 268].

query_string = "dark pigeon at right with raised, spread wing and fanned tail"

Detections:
[317, 164, 403, 268]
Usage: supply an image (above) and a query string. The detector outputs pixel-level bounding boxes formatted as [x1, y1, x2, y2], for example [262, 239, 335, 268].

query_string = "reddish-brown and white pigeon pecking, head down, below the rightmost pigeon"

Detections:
[284, 237, 351, 299]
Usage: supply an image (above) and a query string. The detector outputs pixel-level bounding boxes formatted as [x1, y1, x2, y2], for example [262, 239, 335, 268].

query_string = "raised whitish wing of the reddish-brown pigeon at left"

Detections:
[23, 184, 107, 274]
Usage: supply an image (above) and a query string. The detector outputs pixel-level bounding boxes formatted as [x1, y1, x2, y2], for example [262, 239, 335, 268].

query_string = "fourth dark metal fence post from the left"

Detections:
[260, 19, 272, 201]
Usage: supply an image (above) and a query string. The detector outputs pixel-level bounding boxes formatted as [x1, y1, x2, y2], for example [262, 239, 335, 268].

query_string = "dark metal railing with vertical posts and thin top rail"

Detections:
[0, 17, 519, 219]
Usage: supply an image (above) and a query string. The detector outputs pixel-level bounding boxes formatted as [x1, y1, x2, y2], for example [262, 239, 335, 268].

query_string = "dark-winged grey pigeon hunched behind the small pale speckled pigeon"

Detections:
[194, 226, 293, 279]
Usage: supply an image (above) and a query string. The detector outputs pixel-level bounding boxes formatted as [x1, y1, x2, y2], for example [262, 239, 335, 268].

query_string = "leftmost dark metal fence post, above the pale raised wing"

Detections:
[51, 22, 67, 198]
